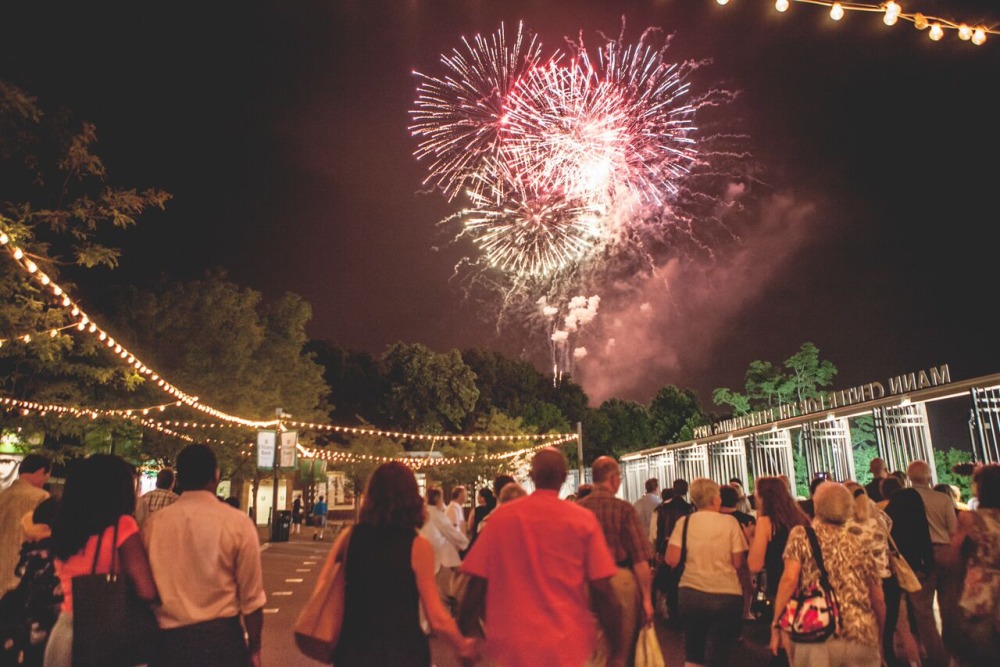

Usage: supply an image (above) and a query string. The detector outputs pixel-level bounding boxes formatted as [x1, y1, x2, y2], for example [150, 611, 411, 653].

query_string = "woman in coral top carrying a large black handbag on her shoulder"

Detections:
[44, 454, 157, 667]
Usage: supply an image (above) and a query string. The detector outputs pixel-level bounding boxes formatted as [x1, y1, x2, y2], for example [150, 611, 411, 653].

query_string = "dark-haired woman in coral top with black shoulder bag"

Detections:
[44, 454, 157, 667]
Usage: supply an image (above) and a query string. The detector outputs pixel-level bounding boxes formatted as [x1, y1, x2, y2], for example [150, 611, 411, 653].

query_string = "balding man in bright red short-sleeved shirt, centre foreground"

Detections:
[458, 447, 631, 667]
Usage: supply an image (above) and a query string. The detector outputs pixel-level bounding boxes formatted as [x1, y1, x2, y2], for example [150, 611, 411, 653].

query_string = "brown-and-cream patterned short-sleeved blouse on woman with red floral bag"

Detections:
[785, 521, 879, 650]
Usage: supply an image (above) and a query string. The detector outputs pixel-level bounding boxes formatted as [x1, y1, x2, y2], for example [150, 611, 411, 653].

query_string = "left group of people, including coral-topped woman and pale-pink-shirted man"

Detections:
[0, 444, 266, 667]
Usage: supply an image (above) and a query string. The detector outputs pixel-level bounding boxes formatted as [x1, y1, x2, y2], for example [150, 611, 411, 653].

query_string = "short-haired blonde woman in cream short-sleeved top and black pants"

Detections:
[666, 477, 747, 667]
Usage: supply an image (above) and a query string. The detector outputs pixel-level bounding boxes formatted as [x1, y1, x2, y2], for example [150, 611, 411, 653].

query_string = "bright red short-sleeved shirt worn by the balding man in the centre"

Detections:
[462, 490, 616, 667]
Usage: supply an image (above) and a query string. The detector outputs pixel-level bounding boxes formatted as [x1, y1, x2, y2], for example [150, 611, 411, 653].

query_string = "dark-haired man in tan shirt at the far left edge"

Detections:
[0, 454, 52, 596]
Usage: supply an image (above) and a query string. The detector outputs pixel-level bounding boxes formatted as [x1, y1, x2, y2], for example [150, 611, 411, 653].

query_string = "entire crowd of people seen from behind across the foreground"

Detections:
[0, 445, 1000, 667]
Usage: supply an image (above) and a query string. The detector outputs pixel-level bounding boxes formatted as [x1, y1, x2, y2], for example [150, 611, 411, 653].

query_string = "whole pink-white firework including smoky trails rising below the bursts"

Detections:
[410, 20, 752, 379]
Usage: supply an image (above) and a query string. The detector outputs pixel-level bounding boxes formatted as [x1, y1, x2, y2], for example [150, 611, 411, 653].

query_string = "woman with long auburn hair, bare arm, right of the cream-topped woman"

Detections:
[747, 477, 809, 665]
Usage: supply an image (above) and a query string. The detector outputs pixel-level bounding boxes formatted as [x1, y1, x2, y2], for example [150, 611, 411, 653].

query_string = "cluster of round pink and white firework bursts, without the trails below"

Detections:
[410, 26, 696, 279]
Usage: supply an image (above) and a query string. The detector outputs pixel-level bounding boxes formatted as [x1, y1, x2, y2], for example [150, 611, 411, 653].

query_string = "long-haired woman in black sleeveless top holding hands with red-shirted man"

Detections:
[330, 461, 476, 667]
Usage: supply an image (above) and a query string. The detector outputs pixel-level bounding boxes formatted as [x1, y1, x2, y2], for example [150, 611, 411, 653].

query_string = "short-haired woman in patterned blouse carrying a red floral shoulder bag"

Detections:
[771, 482, 885, 667]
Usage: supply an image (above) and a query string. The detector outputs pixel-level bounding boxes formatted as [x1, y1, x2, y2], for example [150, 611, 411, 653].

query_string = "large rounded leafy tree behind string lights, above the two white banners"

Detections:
[112, 270, 328, 472]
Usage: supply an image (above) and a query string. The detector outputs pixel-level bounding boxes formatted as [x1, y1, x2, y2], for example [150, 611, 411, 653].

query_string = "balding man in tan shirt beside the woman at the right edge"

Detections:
[906, 460, 958, 667]
